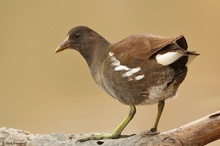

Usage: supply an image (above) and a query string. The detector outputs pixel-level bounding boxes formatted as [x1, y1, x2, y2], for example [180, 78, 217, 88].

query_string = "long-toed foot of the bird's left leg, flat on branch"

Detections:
[76, 133, 135, 143]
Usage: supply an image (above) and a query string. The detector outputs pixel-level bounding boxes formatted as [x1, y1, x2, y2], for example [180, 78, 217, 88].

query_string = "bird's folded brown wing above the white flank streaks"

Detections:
[111, 34, 187, 68]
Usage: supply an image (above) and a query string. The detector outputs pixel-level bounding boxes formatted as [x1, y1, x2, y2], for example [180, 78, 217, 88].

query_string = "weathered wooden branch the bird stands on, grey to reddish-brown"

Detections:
[0, 111, 220, 146]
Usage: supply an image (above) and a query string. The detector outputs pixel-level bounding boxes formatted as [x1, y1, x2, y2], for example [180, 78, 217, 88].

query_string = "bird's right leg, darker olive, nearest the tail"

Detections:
[149, 100, 165, 134]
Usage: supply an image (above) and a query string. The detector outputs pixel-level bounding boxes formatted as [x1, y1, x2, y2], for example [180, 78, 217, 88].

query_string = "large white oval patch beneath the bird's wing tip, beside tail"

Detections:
[156, 52, 183, 65]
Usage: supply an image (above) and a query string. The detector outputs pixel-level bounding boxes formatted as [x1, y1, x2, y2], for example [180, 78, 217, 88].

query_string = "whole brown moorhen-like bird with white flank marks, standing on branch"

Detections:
[55, 26, 199, 142]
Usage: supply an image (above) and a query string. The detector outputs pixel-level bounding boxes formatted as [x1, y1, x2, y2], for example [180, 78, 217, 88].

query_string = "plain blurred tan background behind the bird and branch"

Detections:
[0, 0, 220, 146]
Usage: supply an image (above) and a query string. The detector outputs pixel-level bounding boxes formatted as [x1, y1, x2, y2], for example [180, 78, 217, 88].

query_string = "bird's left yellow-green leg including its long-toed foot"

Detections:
[77, 105, 136, 142]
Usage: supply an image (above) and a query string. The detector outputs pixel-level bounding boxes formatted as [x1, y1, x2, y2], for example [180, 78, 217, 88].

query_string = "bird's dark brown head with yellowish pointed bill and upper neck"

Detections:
[55, 26, 110, 63]
